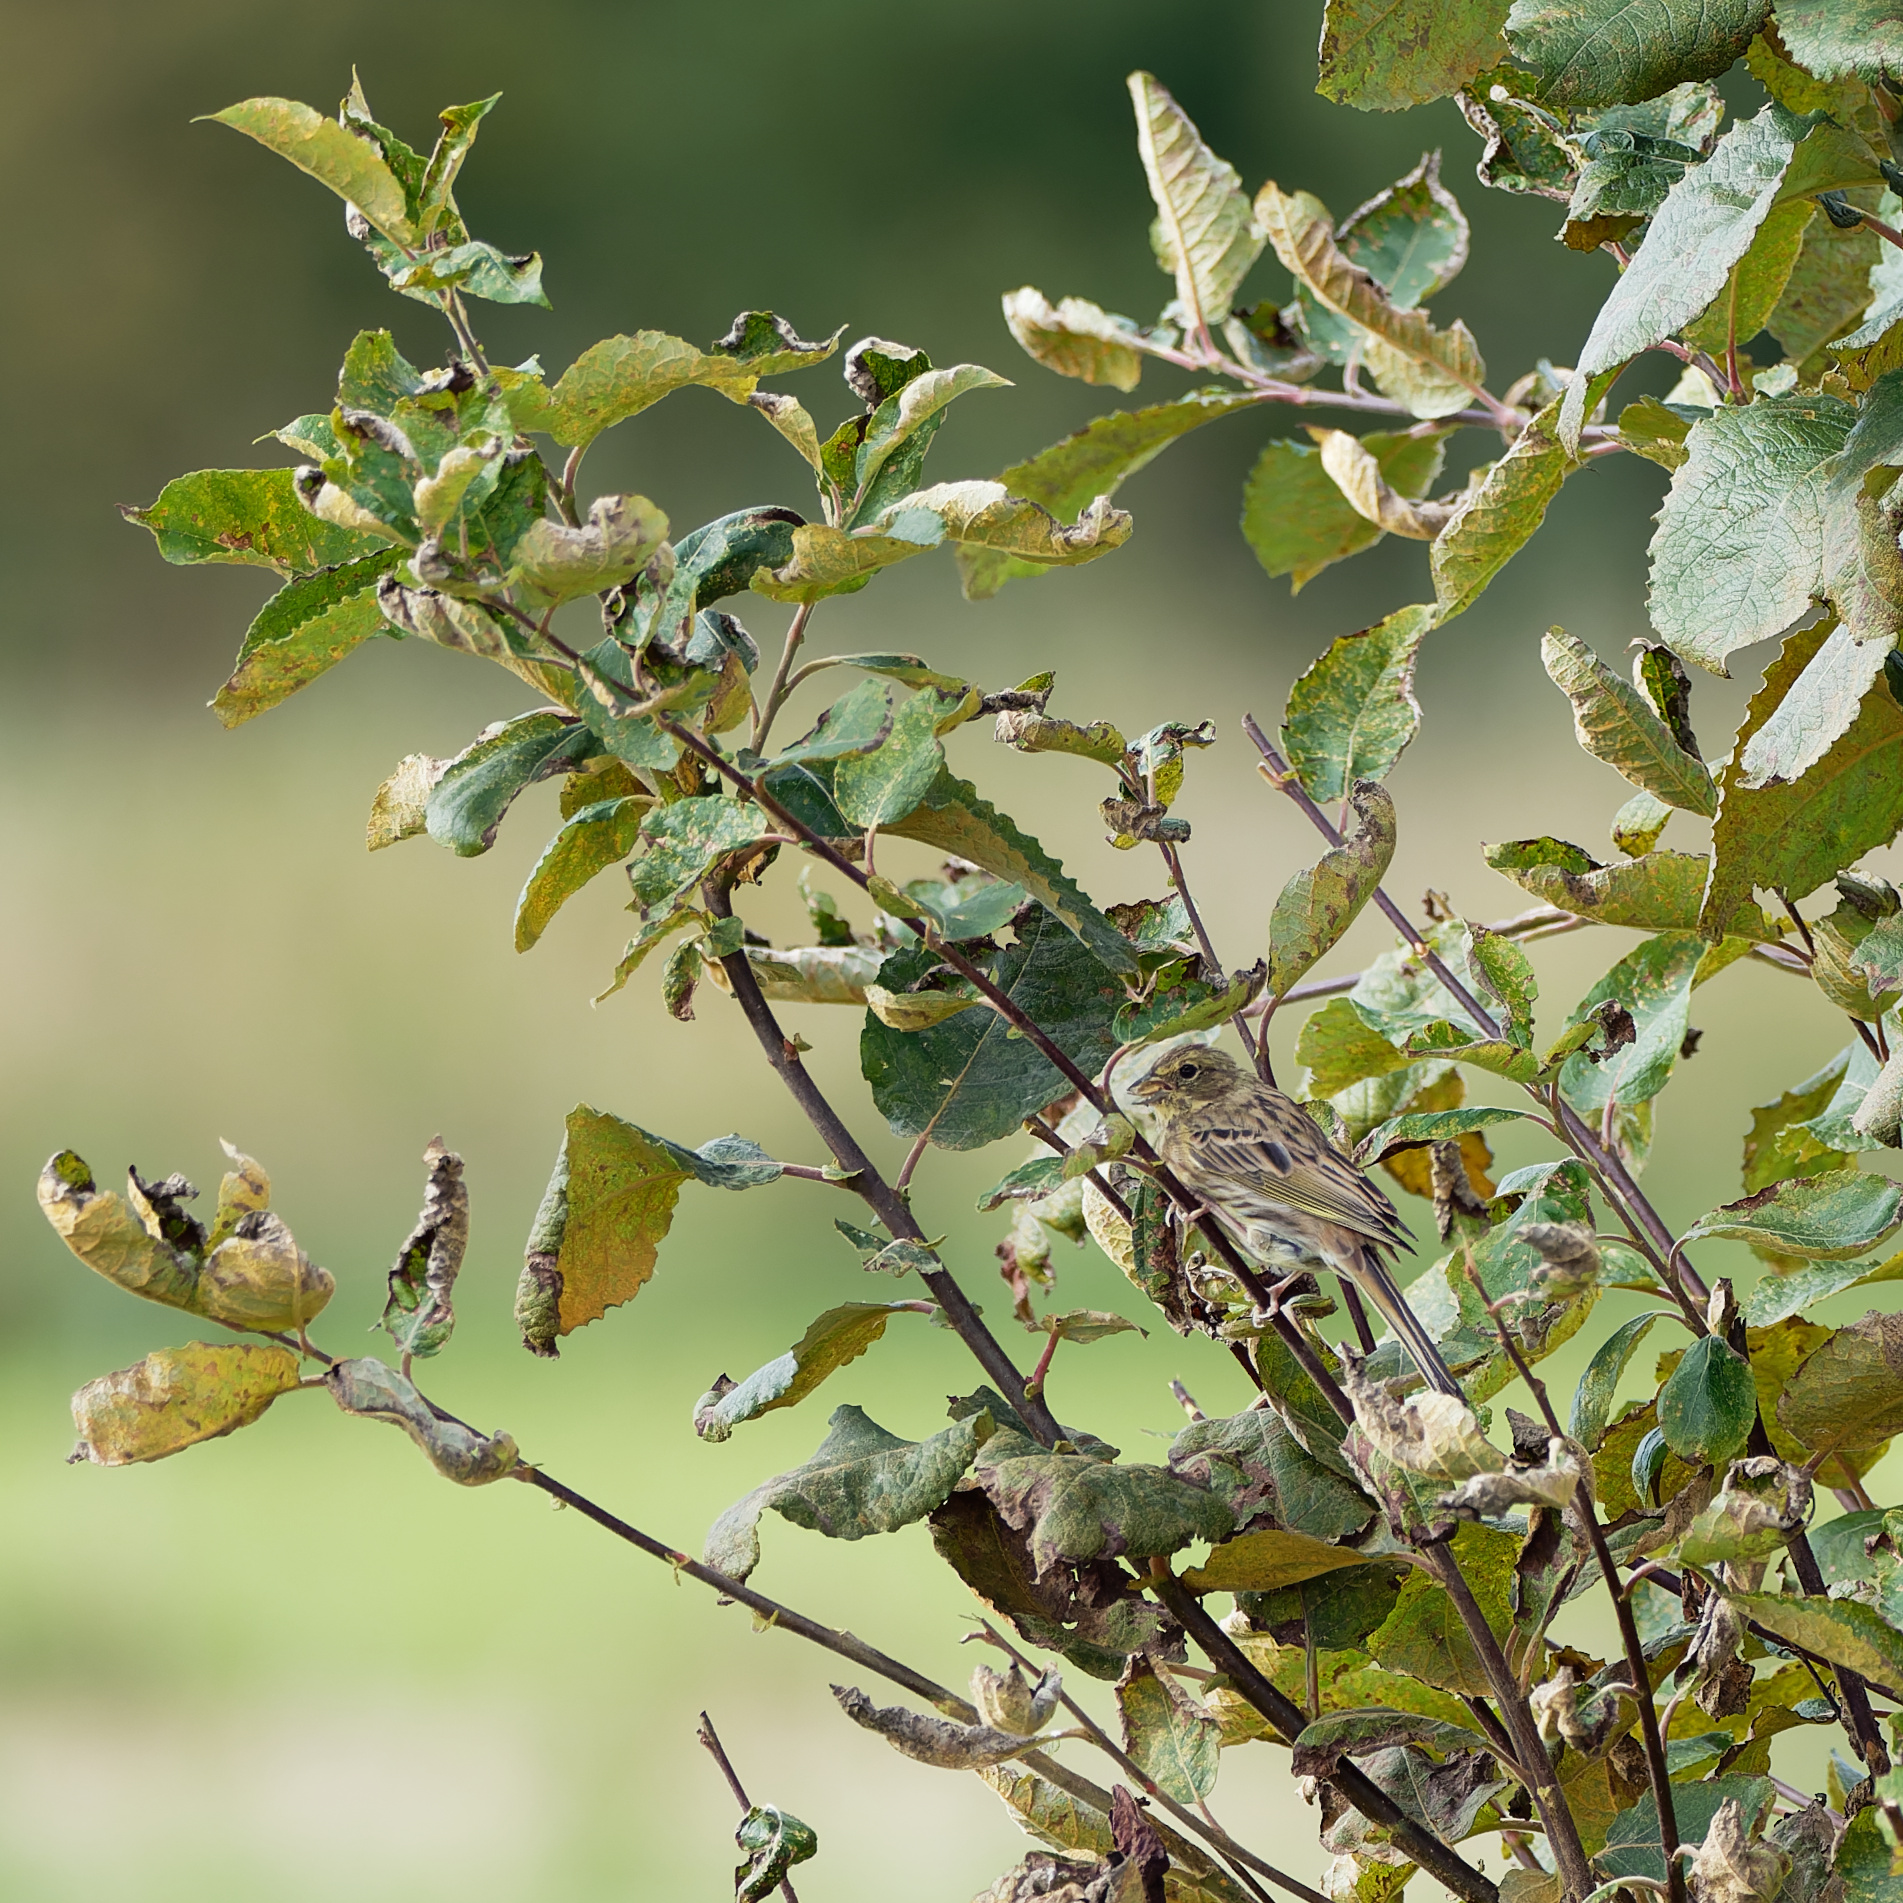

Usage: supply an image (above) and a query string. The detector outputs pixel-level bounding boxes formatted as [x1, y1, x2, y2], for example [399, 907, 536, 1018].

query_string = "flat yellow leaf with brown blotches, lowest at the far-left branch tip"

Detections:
[72, 1342, 299, 1467]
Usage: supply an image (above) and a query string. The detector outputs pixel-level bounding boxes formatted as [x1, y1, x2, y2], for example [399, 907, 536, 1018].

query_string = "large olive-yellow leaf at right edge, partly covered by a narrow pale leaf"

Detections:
[1699, 624, 1903, 934]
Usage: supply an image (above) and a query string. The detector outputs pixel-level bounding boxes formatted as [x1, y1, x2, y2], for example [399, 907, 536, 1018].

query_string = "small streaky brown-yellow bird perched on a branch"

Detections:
[1130, 1045, 1460, 1395]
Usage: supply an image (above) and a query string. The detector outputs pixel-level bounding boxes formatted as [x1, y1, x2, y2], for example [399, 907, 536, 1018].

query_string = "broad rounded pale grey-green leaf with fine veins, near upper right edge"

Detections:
[1644, 390, 1855, 674]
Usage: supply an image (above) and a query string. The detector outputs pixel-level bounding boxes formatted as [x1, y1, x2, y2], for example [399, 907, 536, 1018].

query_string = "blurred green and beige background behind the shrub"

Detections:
[0, 0, 1884, 1903]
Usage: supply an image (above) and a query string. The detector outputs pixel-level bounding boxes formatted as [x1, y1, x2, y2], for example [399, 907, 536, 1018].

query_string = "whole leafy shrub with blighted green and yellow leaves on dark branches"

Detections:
[89, 44, 1903, 1903]
